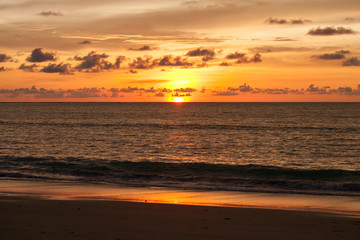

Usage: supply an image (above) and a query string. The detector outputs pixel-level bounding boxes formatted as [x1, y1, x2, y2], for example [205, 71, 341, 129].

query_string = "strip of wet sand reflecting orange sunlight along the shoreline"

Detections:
[0, 181, 360, 216]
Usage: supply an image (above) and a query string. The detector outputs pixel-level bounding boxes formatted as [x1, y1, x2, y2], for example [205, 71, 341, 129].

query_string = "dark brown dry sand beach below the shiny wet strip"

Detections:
[0, 196, 360, 240]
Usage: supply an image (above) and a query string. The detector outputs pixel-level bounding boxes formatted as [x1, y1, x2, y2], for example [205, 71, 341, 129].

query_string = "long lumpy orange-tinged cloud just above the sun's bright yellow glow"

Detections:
[129, 55, 193, 69]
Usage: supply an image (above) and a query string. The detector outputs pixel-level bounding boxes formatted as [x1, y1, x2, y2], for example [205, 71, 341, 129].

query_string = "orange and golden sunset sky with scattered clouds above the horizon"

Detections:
[0, 0, 360, 102]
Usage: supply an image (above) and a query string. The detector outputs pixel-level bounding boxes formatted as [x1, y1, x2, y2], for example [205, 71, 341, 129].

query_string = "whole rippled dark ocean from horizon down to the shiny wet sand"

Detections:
[0, 103, 360, 196]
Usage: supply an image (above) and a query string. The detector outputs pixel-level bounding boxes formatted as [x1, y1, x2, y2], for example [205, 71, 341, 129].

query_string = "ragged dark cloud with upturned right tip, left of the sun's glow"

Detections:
[74, 51, 125, 72]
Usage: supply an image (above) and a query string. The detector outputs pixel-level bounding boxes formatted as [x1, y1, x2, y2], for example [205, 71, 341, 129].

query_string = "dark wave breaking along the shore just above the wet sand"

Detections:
[0, 156, 360, 196]
